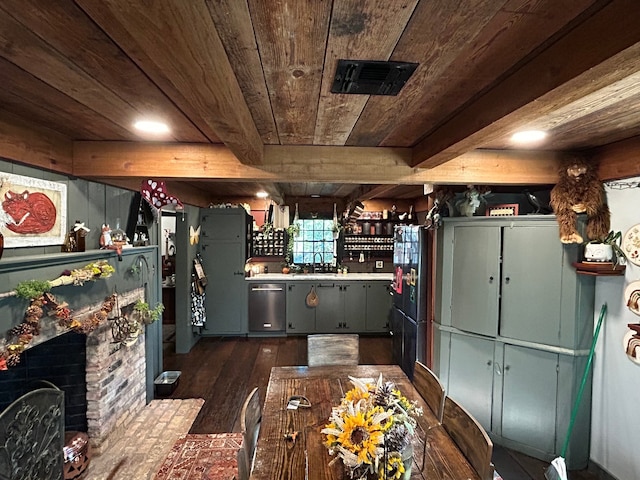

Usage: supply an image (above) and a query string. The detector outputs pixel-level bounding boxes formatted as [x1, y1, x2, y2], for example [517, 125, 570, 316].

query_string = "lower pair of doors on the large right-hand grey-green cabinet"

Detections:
[441, 333, 566, 458]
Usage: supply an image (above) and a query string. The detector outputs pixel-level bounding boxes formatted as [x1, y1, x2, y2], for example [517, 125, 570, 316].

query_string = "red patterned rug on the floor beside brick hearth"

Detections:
[155, 433, 242, 480]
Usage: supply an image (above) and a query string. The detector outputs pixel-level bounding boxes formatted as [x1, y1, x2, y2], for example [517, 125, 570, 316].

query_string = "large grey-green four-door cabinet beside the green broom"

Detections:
[434, 215, 595, 469]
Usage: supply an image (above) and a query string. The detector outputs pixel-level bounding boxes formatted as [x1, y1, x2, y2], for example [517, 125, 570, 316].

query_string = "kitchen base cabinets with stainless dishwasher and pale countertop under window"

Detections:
[246, 273, 393, 335]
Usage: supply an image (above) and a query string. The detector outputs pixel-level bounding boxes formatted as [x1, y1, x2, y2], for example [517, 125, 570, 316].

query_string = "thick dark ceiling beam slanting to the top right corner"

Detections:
[411, 0, 640, 168]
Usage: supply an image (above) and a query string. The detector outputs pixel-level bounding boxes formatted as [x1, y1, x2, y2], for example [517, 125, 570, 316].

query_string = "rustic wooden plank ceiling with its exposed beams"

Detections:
[0, 0, 640, 204]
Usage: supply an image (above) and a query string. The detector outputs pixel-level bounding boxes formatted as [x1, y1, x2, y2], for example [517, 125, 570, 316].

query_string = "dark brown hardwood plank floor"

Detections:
[164, 335, 599, 480]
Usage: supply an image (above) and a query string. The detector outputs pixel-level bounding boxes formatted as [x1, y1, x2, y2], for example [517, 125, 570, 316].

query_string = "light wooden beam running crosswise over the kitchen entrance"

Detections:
[73, 142, 560, 185]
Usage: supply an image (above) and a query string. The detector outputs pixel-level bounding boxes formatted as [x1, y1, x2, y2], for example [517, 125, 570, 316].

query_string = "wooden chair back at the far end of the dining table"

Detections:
[307, 333, 360, 367]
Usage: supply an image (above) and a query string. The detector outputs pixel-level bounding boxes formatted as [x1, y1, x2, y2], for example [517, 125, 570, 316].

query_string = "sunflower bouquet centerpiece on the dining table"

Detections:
[322, 374, 422, 480]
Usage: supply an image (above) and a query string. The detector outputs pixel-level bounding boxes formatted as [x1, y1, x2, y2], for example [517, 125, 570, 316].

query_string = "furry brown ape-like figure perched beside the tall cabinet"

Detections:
[551, 156, 610, 243]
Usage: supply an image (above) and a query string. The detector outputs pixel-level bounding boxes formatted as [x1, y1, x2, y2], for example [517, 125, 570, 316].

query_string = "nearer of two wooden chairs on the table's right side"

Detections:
[442, 396, 494, 480]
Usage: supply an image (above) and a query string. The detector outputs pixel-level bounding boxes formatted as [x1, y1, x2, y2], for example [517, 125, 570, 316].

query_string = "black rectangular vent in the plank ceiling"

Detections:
[331, 60, 418, 95]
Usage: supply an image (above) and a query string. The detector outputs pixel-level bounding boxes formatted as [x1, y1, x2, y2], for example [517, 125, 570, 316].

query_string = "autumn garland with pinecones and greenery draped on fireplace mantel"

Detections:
[0, 260, 117, 370]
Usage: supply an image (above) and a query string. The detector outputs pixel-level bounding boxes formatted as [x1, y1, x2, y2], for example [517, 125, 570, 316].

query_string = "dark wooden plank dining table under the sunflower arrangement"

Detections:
[250, 365, 480, 480]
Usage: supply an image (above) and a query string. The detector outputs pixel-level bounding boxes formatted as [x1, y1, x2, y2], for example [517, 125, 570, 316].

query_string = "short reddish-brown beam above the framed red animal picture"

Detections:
[0, 110, 73, 174]
